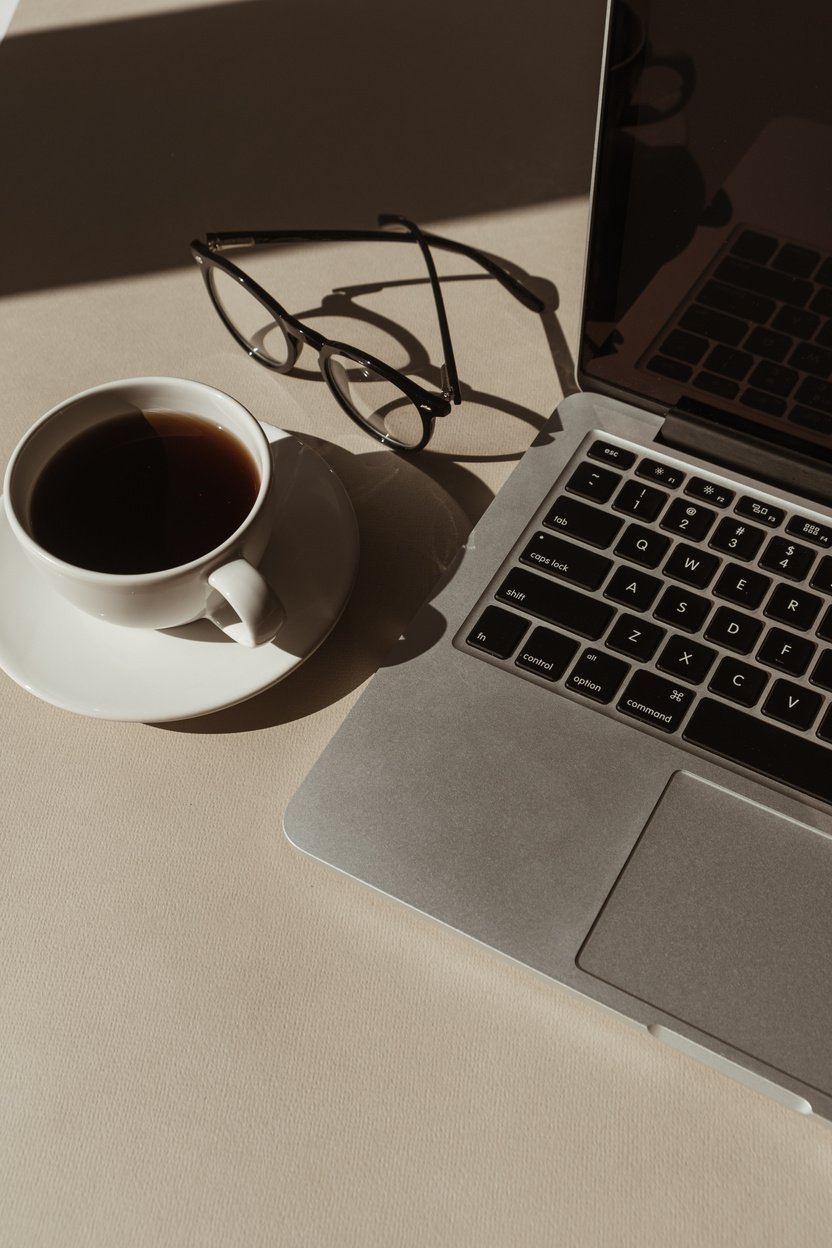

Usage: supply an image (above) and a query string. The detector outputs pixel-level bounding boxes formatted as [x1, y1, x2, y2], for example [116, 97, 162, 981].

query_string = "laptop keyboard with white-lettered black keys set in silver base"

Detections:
[463, 438, 832, 802]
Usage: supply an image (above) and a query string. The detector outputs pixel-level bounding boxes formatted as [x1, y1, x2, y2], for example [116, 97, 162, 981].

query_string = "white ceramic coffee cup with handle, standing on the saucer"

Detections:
[2, 377, 284, 646]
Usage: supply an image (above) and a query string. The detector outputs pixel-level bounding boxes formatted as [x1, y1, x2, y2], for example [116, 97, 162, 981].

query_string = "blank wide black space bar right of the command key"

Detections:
[682, 698, 832, 801]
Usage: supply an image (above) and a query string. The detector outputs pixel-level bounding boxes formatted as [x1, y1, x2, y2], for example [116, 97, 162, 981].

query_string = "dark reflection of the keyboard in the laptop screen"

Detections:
[645, 228, 832, 433]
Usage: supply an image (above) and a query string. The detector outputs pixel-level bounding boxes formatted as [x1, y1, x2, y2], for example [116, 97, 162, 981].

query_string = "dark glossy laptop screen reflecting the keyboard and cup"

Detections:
[580, 0, 832, 459]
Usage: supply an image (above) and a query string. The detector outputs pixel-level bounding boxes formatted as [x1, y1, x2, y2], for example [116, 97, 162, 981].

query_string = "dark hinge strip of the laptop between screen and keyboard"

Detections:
[656, 409, 832, 507]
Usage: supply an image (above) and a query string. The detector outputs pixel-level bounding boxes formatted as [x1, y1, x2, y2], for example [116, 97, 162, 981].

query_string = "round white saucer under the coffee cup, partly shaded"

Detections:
[0, 426, 358, 723]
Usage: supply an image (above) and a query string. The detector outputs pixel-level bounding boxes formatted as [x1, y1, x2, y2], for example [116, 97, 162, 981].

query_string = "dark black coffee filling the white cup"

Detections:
[31, 412, 259, 573]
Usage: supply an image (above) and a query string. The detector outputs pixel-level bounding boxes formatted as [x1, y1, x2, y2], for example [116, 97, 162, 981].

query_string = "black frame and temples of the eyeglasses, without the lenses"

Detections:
[191, 213, 545, 452]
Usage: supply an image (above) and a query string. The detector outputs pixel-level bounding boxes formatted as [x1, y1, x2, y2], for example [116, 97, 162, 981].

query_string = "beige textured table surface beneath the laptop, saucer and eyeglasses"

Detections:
[0, 0, 832, 1248]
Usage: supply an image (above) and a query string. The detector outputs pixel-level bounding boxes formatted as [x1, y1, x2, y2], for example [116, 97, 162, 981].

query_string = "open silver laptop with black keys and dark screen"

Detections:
[284, 0, 832, 1118]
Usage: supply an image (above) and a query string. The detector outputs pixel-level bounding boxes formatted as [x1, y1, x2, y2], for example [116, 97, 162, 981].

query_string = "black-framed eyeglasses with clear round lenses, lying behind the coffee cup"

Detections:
[191, 213, 545, 451]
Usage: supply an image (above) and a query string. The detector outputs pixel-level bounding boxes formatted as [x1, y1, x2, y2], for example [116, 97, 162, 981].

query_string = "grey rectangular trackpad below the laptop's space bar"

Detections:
[578, 773, 832, 1093]
